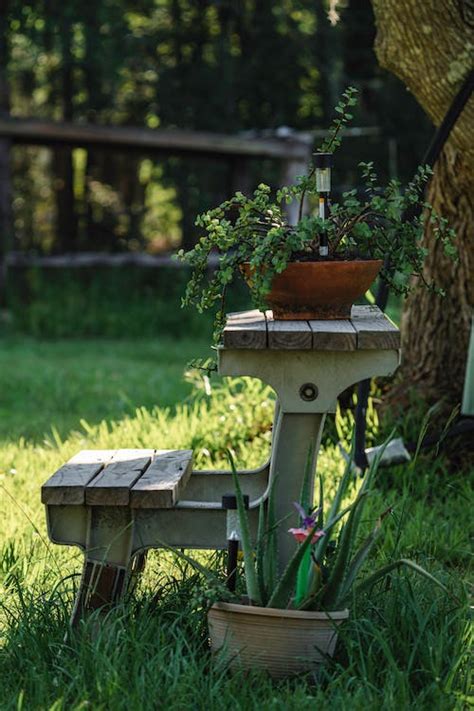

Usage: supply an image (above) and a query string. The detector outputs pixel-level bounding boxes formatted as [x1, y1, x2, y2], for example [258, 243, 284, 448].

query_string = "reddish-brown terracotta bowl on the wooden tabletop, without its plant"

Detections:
[242, 259, 382, 321]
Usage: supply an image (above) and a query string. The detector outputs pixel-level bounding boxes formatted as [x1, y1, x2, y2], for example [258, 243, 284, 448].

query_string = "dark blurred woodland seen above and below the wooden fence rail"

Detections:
[0, 0, 428, 253]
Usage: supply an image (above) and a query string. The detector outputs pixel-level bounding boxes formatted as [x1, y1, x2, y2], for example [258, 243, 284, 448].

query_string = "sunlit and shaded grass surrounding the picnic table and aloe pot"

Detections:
[0, 339, 472, 711]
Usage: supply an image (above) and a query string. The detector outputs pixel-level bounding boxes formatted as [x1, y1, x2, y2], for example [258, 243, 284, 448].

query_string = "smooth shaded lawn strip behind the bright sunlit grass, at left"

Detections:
[0, 338, 211, 440]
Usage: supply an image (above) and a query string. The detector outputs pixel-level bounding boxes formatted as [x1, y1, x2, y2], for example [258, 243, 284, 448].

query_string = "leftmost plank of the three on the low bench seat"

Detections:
[41, 449, 117, 505]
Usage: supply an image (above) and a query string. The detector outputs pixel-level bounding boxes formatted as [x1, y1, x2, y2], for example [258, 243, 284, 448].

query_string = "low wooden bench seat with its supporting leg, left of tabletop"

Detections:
[41, 449, 192, 623]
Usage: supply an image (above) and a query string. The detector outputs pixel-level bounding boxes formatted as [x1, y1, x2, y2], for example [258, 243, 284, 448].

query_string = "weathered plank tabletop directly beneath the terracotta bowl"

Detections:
[223, 306, 400, 351]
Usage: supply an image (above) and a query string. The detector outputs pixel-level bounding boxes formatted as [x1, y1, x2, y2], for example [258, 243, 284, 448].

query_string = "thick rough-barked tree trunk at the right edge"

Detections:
[372, 0, 474, 406]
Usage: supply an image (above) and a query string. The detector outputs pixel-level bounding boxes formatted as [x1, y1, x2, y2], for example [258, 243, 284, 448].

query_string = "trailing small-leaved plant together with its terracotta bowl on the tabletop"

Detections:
[178, 88, 454, 342]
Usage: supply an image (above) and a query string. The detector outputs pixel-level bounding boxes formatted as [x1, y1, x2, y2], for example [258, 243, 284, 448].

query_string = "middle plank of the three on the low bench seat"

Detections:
[86, 449, 155, 506]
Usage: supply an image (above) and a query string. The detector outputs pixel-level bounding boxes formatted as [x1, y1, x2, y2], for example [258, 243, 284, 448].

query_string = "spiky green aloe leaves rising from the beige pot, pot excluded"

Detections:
[229, 444, 449, 611]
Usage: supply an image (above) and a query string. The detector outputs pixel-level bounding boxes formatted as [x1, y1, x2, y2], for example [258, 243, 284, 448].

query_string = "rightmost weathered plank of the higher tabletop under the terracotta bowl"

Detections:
[351, 306, 400, 350]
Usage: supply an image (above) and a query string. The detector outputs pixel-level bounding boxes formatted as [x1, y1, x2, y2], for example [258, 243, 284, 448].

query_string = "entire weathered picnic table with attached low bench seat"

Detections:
[42, 306, 400, 621]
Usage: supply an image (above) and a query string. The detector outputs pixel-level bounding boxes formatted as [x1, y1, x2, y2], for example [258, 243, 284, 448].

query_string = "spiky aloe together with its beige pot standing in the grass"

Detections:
[178, 448, 448, 678]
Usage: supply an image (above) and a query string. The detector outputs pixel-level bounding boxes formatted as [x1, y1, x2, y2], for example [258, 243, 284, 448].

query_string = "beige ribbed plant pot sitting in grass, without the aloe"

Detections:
[208, 602, 349, 679]
